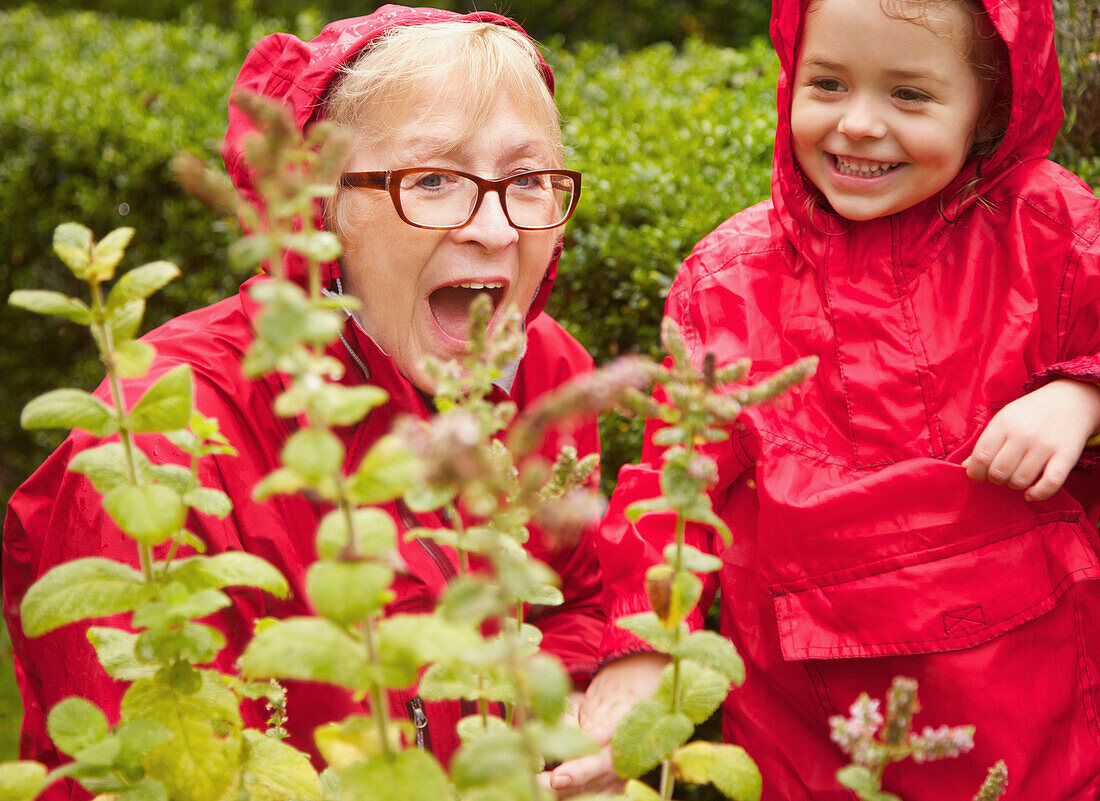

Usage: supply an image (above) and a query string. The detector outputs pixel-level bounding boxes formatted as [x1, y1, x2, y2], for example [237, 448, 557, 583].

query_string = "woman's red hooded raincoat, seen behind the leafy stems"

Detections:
[3, 6, 605, 801]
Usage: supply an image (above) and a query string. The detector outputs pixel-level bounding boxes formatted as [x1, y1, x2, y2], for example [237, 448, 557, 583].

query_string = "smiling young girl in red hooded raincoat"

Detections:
[550, 0, 1100, 801]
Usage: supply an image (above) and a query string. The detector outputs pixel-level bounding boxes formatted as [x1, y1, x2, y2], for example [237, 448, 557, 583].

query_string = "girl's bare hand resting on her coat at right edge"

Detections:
[963, 378, 1100, 501]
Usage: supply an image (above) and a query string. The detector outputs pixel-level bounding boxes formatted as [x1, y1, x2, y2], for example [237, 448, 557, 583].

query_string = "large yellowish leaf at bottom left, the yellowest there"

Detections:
[121, 672, 242, 801]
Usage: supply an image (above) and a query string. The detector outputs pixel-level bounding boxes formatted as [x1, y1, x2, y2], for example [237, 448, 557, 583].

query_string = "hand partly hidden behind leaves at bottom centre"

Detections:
[539, 654, 669, 798]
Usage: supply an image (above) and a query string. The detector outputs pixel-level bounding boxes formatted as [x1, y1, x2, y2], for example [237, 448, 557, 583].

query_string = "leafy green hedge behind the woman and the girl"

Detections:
[0, 0, 1100, 759]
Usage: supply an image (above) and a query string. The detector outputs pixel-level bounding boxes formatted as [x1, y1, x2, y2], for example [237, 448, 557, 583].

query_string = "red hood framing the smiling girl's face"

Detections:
[771, 0, 1063, 269]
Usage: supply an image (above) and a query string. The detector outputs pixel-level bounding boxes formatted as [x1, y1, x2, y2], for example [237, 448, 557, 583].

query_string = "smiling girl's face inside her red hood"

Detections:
[791, 0, 982, 220]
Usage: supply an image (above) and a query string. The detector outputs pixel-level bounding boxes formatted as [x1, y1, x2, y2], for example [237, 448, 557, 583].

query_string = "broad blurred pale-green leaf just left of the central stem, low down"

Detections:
[241, 617, 373, 690]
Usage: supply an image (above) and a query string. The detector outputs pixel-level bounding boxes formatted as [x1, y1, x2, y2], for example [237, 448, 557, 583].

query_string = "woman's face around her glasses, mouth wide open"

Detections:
[338, 95, 561, 393]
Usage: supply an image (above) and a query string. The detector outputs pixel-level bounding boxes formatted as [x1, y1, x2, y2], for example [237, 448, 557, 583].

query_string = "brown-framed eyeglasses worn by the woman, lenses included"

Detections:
[340, 167, 581, 231]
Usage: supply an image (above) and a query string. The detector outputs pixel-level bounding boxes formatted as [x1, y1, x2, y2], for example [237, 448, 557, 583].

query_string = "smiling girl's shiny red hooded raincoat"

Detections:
[598, 0, 1100, 801]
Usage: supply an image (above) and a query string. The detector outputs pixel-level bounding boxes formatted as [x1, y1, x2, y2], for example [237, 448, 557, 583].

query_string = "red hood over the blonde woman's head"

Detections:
[221, 6, 561, 320]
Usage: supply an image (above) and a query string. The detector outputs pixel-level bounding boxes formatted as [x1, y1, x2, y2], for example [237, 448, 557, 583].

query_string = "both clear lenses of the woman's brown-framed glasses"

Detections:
[400, 169, 574, 228]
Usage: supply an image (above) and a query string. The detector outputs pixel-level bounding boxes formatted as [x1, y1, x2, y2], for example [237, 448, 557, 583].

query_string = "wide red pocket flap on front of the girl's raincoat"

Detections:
[771, 512, 1100, 660]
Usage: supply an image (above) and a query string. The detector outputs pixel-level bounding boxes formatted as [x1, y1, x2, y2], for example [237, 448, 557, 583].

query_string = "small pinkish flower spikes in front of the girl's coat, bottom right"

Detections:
[829, 676, 1008, 801]
